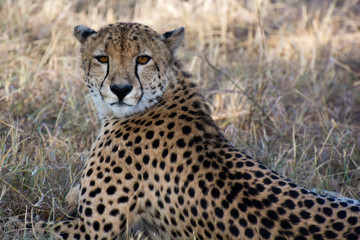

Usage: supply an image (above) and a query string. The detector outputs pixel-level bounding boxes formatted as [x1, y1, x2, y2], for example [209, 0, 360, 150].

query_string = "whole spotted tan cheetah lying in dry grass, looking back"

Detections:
[3, 23, 360, 240]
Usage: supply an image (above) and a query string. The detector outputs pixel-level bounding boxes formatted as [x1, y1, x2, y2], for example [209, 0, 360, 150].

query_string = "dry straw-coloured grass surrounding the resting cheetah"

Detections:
[0, 0, 360, 239]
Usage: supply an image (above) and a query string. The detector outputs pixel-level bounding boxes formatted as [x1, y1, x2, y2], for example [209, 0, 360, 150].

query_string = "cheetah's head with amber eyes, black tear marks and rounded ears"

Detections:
[75, 23, 184, 119]
